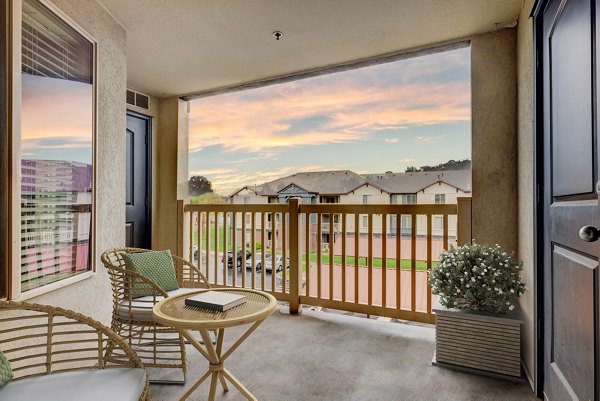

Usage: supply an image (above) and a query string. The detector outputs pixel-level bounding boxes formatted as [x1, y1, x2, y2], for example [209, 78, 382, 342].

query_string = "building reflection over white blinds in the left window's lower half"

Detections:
[21, 160, 92, 289]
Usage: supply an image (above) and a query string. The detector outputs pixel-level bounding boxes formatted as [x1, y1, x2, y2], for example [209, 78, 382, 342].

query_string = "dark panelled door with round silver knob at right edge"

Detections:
[540, 0, 600, 401]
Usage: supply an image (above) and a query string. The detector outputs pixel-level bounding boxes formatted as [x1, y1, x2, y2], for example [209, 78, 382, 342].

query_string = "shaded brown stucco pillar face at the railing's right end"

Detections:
[471, 28, 518, 251]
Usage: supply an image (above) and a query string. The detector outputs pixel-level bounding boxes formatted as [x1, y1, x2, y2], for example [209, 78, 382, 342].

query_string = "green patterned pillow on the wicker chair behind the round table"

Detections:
[121, 249, 179, 298]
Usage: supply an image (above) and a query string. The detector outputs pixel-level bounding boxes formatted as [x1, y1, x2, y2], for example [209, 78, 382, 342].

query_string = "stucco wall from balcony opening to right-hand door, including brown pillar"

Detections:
[471, 25, 537, 387]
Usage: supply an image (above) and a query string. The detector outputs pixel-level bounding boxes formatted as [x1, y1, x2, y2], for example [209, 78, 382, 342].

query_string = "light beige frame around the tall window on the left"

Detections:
[8, 0, 98, 301]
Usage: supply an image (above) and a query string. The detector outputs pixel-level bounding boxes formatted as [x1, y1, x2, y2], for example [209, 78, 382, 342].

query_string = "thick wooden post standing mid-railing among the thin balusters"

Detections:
[288, 198, 302, 315]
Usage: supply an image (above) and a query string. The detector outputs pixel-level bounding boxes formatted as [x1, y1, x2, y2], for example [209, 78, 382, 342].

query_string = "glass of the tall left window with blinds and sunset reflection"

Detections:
[20, 0, 94, 292]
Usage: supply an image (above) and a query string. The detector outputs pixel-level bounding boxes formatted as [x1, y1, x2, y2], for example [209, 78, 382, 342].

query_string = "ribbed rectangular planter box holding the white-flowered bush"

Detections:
[433, 304, 523, 380]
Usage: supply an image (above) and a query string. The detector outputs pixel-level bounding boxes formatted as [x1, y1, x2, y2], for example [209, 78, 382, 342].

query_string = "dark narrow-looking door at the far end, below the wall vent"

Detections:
[125, 111, 152, 249]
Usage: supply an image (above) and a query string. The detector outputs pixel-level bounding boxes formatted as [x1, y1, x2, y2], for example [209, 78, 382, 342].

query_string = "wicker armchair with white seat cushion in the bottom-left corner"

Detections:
[0, 301, 151, 401]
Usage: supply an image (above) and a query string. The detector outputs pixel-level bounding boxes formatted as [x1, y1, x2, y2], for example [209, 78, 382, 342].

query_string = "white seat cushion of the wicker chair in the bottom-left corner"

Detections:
[0, 368, 146, 401]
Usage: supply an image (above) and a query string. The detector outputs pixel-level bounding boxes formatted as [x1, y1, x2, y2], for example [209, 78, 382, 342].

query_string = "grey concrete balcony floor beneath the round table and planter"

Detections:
[152, 306, 536, 401]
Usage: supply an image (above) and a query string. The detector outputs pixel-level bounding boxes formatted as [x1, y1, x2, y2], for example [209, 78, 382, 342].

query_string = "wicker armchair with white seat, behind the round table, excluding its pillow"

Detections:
[101, 248, 210, 383]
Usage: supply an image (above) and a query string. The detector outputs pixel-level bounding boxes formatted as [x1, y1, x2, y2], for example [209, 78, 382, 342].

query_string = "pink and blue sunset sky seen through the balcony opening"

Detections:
[189, 48, 471, 195]
